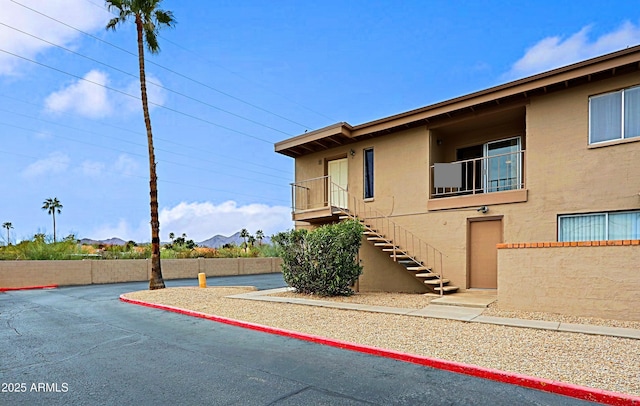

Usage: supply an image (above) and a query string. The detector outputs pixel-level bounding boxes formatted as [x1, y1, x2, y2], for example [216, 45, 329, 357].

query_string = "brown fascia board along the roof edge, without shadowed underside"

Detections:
[275, 45, 640, 156]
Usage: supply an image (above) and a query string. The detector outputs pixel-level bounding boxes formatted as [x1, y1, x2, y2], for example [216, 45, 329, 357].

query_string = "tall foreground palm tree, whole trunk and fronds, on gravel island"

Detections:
[106, 0, 175, 290]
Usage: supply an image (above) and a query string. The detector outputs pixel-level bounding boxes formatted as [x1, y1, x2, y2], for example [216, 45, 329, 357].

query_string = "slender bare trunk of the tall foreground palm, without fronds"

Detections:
[136, 14, 165, 290]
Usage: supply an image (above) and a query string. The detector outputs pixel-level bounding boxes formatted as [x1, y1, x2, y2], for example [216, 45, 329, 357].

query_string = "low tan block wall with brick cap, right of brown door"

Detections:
[498, 240, 640, 321]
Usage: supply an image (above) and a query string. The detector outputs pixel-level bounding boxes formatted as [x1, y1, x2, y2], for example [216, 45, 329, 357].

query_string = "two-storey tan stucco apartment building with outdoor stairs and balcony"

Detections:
[275, 46, 640, 320]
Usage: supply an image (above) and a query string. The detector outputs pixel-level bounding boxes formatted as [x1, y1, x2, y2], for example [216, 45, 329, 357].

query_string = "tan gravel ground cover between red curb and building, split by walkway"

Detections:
[125, 287, 640, 396]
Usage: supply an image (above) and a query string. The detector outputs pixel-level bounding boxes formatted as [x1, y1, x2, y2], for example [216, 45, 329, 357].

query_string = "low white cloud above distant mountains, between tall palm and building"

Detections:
[160, 200, 293, 241]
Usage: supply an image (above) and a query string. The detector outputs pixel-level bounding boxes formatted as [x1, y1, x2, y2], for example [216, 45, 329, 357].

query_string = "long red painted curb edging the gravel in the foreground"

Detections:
[120, 295, 640, 406]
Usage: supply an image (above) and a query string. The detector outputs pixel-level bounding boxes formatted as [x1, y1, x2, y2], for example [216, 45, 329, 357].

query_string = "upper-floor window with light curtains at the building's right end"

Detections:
[589, 86, 640, 144]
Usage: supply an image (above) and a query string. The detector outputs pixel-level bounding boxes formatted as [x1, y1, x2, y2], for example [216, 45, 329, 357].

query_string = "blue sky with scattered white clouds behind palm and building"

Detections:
[0, 0, 640, 242]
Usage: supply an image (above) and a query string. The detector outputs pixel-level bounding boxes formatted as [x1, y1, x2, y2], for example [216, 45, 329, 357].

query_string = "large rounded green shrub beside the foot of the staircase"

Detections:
[273, 220, 364, 296]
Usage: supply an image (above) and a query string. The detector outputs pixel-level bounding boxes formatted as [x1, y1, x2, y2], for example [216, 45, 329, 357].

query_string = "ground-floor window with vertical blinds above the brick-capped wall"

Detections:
[558, 210, 640, 241]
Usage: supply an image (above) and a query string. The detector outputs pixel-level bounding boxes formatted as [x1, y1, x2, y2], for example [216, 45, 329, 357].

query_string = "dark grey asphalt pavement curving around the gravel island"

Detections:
[0, 274, 591, 405]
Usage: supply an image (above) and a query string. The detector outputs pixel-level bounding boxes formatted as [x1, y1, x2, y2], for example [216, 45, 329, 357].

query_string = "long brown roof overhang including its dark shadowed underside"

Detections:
[275, 45, 640, 158]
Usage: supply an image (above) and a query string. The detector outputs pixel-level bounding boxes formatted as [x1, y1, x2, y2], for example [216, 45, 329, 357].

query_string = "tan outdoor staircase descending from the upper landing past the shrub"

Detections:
[334, 208, 458, 295]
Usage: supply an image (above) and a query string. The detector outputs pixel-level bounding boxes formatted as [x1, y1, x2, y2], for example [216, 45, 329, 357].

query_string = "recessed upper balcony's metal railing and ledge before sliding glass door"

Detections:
[428, 150, 527, 210]
